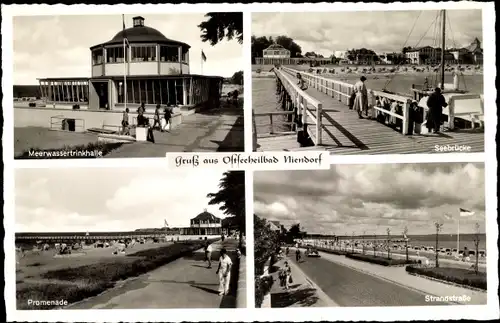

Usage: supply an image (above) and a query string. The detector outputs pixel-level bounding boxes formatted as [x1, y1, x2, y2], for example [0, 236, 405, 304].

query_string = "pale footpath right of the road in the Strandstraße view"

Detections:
[314, 252, 487, 305]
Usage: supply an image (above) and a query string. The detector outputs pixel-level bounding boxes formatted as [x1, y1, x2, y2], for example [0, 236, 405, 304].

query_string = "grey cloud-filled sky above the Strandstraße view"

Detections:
[254, 163, 485, 235]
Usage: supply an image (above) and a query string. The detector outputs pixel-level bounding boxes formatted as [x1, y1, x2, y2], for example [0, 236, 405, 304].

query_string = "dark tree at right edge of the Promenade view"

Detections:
[207, 171, 245, 247]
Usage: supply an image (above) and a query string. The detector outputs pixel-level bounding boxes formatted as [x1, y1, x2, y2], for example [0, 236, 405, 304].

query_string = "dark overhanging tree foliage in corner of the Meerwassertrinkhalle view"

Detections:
[198, 12, 243, 46]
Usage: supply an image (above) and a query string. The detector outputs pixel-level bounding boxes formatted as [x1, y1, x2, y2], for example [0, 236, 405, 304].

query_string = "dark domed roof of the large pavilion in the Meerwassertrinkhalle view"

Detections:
[90, 17, 191, 49]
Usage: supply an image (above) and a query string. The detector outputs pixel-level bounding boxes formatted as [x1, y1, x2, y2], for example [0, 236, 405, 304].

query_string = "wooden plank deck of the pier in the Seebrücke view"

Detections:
[266, 74, 484, 155]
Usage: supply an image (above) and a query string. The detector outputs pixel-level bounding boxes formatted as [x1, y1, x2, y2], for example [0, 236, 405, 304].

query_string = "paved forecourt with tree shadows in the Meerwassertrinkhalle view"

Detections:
[105, 108, 245, 158]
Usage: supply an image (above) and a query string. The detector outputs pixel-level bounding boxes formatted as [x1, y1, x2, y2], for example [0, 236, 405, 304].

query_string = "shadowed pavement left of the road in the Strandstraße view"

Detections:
[271, 257, 338, 308]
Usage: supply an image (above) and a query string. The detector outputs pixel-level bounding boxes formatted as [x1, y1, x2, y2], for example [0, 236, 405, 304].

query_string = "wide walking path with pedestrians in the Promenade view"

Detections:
[68, 239, 238, 309]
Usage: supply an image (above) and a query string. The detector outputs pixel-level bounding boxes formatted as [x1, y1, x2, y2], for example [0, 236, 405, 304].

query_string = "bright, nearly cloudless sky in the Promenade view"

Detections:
[15, 166, 229, 232]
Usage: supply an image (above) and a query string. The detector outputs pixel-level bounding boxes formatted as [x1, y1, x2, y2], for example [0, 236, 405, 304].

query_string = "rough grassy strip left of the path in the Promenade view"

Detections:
[16, 241, 202, 310]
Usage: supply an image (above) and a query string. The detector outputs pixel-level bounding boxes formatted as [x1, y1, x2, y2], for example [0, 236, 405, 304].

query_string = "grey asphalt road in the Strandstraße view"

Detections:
[290, 248, 447, 306]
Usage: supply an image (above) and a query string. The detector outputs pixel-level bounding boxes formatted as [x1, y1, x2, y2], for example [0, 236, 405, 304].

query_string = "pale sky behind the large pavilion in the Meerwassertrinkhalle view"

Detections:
[13, 13, 244, 85]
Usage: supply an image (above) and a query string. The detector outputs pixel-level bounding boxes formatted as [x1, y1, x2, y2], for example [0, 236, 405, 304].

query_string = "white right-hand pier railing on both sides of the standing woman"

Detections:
[280, 66, 411, 135]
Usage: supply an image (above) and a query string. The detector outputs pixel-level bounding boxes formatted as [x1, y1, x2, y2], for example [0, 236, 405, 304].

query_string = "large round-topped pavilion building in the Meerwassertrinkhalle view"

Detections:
[16, 16, 223, 132]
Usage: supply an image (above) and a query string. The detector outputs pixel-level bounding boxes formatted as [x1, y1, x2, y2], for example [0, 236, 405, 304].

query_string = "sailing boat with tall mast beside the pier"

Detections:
[382, 9, 484, 134]
